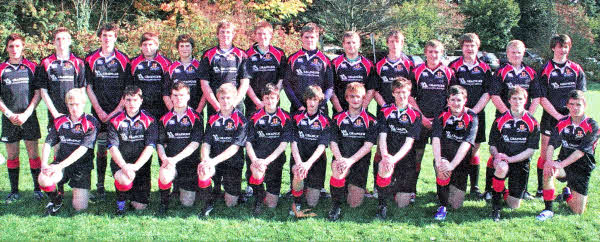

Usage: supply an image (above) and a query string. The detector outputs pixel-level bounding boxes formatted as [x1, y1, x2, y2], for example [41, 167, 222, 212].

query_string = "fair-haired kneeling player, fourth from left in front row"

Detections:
[197, 82, 248, 217]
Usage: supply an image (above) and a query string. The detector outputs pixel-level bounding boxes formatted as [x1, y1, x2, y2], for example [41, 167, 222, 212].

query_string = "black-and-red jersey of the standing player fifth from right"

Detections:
[375, 54, 414, 104]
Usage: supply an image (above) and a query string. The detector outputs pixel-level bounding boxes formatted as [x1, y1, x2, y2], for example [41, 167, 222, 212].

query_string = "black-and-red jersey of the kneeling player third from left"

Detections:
[158, 107, 204, 164]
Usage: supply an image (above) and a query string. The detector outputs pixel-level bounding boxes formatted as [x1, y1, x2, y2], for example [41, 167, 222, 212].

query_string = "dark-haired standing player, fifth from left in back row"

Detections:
[163, 34, 206, 112]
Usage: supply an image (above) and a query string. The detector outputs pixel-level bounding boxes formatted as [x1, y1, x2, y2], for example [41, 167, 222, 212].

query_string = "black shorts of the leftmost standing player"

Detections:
[0, 112, 41, 143]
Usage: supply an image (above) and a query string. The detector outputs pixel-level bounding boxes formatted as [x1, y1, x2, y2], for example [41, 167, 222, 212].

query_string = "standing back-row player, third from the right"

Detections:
[448, 33, 492, 198]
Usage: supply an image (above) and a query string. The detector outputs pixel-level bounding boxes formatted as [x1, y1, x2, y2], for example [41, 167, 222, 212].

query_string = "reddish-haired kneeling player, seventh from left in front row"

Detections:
[329, 82, 378, 221]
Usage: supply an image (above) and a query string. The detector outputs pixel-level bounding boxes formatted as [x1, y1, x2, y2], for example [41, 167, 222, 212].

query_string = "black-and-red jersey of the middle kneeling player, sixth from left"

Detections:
[293, 110, 331, 156]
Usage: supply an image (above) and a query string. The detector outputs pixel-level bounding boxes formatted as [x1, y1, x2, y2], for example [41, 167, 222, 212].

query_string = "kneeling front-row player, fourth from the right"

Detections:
[375, 77, 422, 219]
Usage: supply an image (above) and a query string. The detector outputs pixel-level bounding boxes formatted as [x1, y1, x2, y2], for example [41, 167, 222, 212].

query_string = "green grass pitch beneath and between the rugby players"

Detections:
[0, 84, 600, 241]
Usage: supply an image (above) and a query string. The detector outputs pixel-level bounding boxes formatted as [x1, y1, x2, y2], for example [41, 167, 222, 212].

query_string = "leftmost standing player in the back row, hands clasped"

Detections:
[0, 34, 44, 204]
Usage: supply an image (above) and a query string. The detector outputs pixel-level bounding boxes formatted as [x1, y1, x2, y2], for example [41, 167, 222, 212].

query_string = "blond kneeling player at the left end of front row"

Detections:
[38, 89, 99, 216]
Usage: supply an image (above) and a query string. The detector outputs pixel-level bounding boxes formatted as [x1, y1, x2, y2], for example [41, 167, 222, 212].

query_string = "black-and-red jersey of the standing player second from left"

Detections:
[35, 53, 86, 116]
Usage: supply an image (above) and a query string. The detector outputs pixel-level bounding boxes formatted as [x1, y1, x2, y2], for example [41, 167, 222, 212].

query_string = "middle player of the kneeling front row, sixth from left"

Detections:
[290, 86, 330, 217]
